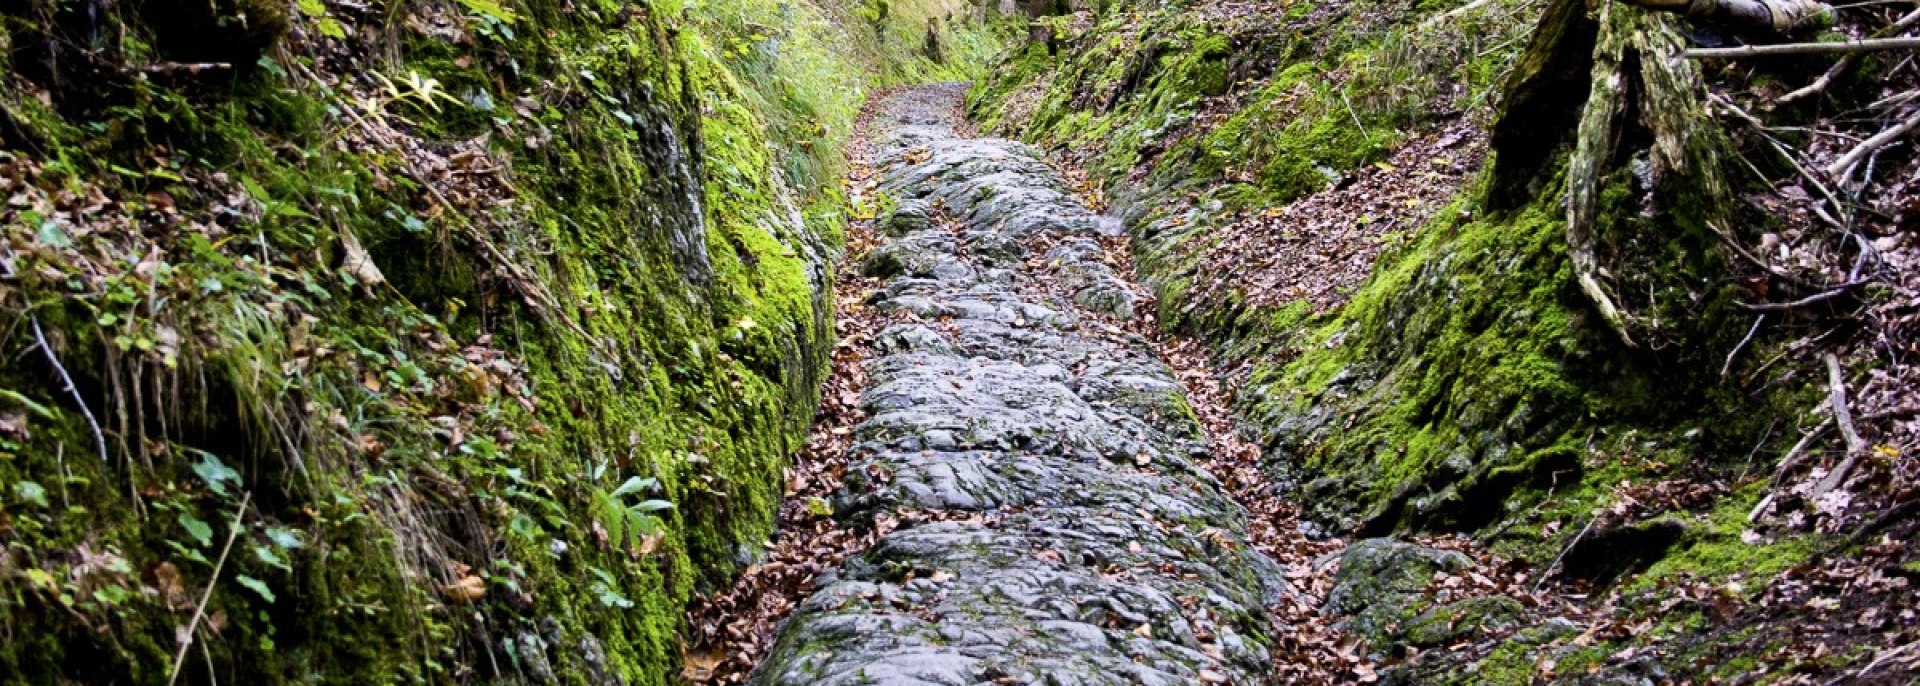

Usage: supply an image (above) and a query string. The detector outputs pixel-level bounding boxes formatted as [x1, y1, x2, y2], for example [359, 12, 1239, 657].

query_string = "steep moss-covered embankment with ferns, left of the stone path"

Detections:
[0, 0, 991, 684]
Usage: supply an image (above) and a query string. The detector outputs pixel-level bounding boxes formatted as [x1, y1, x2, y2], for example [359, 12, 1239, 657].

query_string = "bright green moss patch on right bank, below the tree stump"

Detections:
[1256, 195, 1594, 519]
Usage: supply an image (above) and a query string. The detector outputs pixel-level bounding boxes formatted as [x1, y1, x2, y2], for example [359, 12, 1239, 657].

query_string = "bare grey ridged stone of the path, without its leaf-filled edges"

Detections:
[755, 86, 1286, 686]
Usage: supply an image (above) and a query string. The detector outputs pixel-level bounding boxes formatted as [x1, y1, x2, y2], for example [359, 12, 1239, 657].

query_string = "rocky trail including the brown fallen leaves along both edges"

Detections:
[689, 86, 1420, 684]
